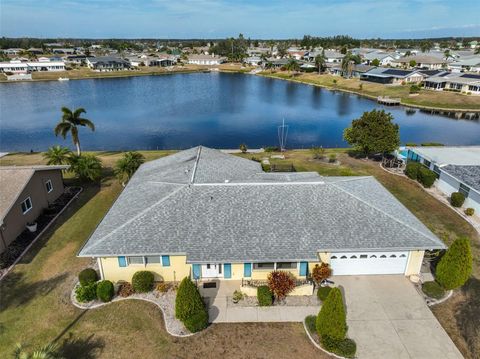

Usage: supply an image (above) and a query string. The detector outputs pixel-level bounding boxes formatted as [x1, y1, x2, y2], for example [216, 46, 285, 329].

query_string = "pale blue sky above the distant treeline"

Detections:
[0, 0, 480, 38]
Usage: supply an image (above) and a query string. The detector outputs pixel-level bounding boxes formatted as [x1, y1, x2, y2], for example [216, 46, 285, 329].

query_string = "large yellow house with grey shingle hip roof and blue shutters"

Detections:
[79, 147, 445, 281]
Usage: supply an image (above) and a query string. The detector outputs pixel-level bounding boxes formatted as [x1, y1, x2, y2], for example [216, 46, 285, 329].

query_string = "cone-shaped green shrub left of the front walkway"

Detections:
[175, 277, 208, 333]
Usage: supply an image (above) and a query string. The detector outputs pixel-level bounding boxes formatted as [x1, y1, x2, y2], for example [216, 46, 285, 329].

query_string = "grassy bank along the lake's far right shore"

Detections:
[261, 71, 480, 111]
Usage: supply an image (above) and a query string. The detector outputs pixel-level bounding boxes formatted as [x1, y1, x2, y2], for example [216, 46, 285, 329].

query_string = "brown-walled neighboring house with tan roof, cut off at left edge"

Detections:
[0, 166, 69, 253]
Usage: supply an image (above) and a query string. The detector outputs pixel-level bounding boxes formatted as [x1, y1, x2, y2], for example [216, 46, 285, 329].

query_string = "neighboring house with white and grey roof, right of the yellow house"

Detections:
[407, 146, 480, 215]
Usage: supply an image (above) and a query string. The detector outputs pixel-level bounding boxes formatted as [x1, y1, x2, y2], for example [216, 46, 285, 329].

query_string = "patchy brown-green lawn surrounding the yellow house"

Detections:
[0, 149, 480, 358]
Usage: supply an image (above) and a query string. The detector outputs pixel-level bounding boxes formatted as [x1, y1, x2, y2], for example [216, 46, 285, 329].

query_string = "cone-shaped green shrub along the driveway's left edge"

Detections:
[316, 288, 347, 340]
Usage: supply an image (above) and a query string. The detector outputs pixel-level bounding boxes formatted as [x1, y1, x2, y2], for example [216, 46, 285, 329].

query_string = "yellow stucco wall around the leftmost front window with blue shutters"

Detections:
[100, 256, 191, 282]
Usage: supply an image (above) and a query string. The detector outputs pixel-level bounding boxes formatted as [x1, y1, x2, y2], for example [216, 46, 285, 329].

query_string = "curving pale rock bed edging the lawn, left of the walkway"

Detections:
[70, 282, 195, 337]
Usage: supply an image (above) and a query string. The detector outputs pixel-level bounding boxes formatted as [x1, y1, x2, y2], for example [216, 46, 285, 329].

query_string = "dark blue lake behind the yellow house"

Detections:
[0, 73, 480, 151]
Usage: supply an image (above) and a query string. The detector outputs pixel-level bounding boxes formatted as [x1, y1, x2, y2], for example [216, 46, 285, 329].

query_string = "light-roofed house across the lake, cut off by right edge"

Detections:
[425, 72, 480, 95]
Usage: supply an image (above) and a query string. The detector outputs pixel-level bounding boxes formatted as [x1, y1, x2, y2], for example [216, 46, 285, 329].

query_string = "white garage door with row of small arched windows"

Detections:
[330, 252, 408, 275]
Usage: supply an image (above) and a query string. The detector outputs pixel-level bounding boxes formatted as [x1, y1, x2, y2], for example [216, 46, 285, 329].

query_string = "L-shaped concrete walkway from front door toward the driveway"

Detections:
[200, 281, 320, 323]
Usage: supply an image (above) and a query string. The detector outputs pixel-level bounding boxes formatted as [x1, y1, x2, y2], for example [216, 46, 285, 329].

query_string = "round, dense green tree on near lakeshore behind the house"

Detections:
[343, 110, 400, 156]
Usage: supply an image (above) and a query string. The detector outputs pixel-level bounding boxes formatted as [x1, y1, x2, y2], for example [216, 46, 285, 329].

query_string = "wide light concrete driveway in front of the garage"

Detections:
[333, 275, 463, 359]
